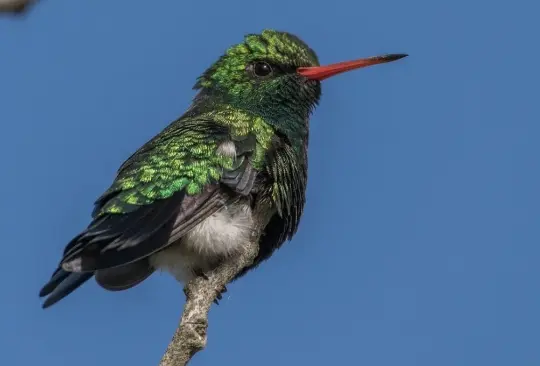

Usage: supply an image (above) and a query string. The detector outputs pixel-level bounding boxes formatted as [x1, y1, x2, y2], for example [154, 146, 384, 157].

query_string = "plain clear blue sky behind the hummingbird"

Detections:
[0, 0, 540, 366]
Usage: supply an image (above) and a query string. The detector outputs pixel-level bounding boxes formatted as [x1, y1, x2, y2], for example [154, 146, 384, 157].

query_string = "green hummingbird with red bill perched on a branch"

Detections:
[39, 29, 407, 308]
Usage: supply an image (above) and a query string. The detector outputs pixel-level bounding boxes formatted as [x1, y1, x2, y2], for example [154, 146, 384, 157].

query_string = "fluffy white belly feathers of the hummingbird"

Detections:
[150, 204, 253, 283]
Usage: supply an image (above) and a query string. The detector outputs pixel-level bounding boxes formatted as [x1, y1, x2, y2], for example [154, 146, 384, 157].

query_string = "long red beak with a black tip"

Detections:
[296, 53, 408, 81]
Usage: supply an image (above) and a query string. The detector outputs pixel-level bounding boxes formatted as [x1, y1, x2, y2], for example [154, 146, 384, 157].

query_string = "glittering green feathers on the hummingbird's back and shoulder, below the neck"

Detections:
[97, 105, 274, 216]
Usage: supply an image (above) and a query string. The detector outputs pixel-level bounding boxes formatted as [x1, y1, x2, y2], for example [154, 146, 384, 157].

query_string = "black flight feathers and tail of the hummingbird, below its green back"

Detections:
[39, 184, 230, 307]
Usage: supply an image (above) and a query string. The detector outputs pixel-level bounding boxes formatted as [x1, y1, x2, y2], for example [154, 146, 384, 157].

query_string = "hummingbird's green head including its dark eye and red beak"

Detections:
[195, 29, 406, 133]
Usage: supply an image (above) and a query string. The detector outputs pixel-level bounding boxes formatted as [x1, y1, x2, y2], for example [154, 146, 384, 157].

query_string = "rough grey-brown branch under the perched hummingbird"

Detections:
[159, 230, 259, 366]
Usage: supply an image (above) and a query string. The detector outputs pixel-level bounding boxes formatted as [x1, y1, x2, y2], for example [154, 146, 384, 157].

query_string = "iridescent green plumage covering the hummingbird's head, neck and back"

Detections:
[96, 30, 318, 216]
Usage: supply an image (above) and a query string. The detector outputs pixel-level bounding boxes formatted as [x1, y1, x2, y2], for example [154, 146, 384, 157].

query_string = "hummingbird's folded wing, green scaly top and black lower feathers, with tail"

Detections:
[40, 120, 256, 307]
